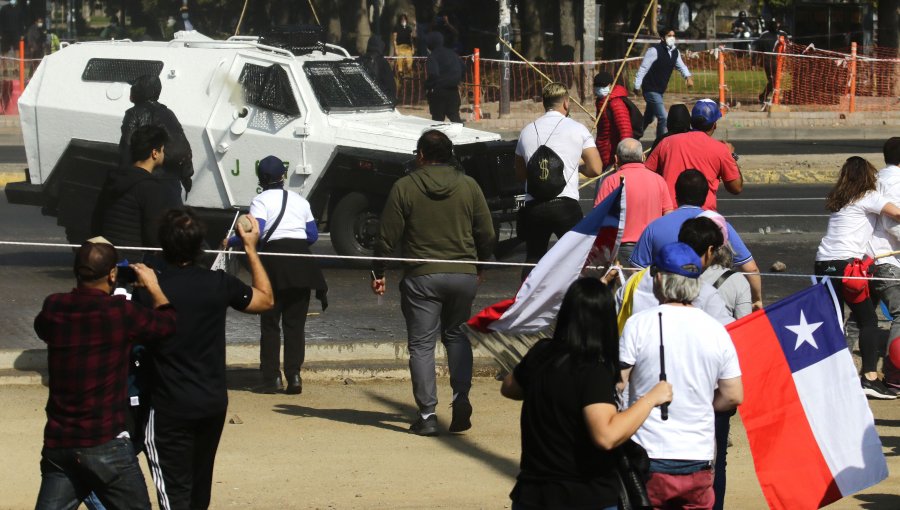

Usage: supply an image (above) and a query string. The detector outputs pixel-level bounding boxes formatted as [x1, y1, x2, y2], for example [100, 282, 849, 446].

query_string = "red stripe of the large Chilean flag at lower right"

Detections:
[728, 311, 841, 510]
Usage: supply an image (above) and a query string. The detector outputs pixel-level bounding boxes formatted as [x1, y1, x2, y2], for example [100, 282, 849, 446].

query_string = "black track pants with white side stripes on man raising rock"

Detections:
[146, 409, 225, 510]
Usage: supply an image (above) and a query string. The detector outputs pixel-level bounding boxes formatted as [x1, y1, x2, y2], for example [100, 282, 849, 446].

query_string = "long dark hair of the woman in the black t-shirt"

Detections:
[553, 278, 619, 381]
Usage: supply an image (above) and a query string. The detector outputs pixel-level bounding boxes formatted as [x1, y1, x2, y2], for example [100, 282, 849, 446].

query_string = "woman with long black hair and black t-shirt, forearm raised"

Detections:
[500, 278, 672, 510]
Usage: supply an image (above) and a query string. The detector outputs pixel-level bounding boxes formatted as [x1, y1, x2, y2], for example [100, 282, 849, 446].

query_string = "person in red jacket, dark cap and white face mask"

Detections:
[594, 71, 634, 168]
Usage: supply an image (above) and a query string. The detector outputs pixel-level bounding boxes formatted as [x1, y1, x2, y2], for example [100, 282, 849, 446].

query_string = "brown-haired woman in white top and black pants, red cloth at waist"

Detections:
[815, 156, 900, 400]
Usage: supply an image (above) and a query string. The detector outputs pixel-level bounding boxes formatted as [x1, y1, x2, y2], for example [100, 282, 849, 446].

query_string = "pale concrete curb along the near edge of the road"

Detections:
[0, 342, 498, 386]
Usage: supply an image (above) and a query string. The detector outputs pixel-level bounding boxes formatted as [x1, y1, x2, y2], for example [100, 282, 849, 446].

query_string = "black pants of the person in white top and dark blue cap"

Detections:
[259, 288, 310, 381]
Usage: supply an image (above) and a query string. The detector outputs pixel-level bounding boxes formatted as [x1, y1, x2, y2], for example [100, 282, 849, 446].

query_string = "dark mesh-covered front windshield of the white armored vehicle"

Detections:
[304, 60, 394, 111]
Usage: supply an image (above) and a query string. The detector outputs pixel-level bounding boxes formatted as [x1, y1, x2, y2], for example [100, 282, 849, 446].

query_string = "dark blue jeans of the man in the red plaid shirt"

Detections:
[35, 438, 150, 510]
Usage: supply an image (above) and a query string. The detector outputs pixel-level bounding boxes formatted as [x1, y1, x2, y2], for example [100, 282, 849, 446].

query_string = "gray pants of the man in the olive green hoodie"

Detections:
[400, 273, 478, 414]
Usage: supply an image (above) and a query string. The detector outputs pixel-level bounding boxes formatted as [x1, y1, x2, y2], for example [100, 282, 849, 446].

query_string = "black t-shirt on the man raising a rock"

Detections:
[141, 266, 253, 419]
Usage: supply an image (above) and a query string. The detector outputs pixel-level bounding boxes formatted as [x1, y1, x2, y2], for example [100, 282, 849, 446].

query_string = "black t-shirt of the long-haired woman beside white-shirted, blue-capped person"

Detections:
[510, 340, 618, 509]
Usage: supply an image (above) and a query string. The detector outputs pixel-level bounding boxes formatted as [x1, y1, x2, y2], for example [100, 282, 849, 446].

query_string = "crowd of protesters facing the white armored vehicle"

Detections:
[34, 25, 900, 509]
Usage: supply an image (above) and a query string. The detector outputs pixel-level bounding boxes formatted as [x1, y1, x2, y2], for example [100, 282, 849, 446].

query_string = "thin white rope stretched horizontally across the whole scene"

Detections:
[0, 241, 900, 281]
